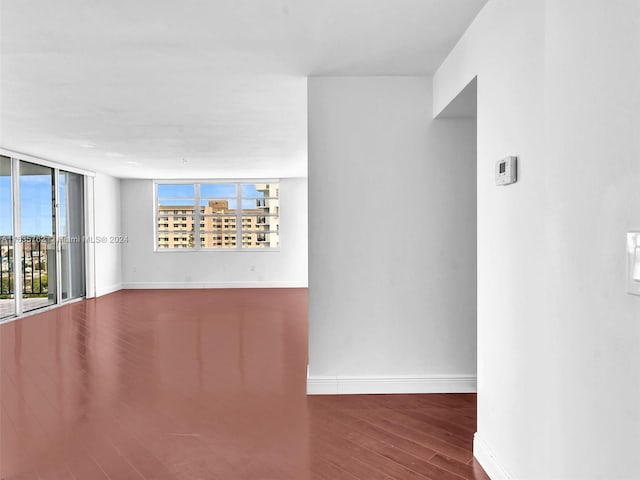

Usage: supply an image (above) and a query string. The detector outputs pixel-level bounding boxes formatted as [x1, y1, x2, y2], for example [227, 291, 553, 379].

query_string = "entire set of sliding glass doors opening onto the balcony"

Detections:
[0, 155, 87, 321]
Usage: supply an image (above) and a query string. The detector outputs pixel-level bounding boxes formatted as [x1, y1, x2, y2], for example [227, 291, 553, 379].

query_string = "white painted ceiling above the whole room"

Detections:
[0, 0, 487, 178]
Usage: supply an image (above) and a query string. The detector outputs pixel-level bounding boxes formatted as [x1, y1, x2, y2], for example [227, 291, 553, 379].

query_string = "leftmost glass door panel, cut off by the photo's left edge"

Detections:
[0, 156, 16, 318]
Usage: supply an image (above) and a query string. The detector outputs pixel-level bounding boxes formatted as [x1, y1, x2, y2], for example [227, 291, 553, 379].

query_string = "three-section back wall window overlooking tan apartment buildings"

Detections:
[155, 181, 280, 250]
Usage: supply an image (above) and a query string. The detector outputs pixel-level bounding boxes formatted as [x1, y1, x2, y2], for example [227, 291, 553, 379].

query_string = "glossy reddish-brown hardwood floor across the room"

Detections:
[0, 289, 488, 480]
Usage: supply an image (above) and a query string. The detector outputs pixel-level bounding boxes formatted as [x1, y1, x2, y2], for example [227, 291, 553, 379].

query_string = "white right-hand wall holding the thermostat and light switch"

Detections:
[434, 0, 640, 480]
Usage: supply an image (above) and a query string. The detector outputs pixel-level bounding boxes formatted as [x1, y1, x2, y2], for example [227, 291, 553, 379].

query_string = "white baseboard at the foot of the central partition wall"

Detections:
[307, 375, 476, 395]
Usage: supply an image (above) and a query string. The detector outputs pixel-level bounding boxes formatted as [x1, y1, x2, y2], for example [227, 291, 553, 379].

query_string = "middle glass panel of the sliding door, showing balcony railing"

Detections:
[20, 161, 57, 312]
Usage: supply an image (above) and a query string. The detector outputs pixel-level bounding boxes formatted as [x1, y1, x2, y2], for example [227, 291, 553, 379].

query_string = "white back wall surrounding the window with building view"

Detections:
[122, 178, 307, 288]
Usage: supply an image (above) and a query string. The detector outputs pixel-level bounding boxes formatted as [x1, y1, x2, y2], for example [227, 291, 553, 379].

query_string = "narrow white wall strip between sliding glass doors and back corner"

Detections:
[93, 173, 122, 296]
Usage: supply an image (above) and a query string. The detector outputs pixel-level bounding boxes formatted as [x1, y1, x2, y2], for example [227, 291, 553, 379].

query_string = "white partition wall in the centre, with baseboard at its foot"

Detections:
[308, 77, 476, 393]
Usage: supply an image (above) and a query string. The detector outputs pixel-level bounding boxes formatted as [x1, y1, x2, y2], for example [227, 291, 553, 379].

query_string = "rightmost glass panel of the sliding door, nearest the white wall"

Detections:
[58, 170, 86, 301]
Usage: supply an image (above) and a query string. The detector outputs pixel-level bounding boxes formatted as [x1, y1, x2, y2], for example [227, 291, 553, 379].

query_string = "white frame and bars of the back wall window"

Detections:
[153, 178, 281, 253]
